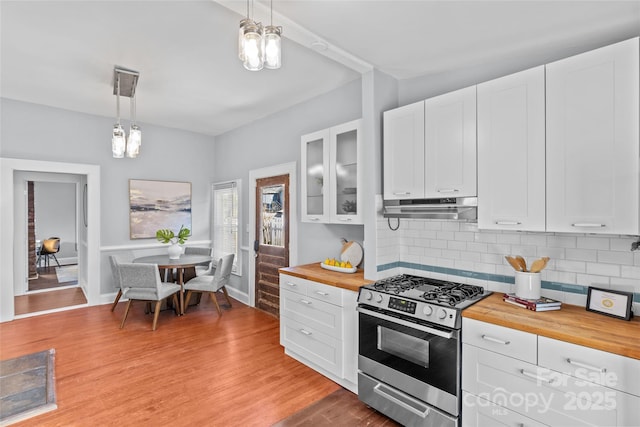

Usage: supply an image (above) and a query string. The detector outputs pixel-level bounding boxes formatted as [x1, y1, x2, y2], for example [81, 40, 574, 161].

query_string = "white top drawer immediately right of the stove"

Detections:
[462, 318, 538, 364]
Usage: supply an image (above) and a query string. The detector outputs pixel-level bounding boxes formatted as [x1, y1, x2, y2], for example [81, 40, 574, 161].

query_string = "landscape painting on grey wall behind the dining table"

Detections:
[129, 179, 191, 239]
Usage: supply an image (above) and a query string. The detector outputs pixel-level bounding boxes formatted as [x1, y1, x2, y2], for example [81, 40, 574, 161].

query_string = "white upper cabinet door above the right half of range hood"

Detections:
[424, 86, 477, 198]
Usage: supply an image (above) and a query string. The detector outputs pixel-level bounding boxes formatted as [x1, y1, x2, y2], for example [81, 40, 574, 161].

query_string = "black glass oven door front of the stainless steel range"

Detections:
[358, 313, 460, 396]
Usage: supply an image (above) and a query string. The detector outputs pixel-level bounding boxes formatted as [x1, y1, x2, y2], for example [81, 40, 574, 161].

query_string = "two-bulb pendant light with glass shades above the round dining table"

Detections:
[111, 67, 142, 159]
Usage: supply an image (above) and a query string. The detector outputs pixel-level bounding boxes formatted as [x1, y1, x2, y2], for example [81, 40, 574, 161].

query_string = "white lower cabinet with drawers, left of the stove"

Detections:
[280, 274, 358, 393]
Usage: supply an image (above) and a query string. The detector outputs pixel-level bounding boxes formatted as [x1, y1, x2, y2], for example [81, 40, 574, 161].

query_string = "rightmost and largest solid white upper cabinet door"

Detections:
[546, 38, 640, 235]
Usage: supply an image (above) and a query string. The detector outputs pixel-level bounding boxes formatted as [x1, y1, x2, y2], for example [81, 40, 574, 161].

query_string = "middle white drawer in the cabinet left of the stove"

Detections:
[280, 289, 342, 339]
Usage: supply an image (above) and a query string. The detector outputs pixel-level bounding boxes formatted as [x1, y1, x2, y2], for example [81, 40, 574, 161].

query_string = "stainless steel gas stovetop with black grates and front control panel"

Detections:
[358, 274, 491, 329]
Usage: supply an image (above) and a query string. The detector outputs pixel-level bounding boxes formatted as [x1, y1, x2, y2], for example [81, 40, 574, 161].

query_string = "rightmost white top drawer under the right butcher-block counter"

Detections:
[538, 332, 640, 396]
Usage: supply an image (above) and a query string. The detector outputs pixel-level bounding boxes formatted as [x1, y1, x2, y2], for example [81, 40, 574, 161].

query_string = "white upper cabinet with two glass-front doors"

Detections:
[301, 120, 363, 224]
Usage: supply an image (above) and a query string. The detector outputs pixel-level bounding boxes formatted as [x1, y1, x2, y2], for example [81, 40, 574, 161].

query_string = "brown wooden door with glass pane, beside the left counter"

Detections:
[254, 175, 289, 317]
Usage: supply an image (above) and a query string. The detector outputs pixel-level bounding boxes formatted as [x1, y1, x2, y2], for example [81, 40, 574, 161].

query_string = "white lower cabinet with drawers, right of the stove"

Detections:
[462, 318, 640, 426]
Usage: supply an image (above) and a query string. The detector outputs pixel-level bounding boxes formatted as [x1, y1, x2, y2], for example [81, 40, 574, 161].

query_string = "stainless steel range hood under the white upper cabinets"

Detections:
[383, 197, 478, 222]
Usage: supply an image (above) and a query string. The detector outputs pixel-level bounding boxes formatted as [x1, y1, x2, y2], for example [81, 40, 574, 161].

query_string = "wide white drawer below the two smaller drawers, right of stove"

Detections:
[463, 344, 624, 427]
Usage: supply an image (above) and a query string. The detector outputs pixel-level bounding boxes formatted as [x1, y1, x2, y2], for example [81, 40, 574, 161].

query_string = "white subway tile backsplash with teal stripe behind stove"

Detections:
[376, 218, 640, 307]
